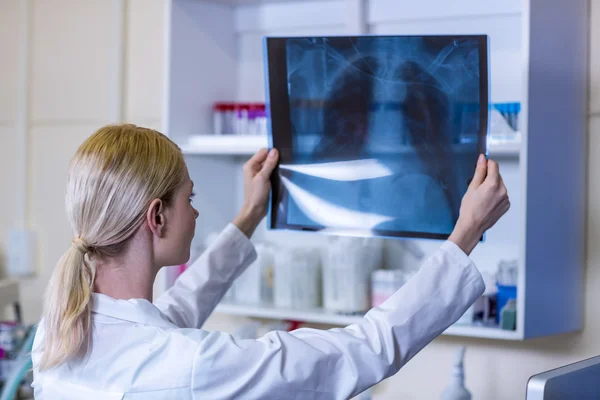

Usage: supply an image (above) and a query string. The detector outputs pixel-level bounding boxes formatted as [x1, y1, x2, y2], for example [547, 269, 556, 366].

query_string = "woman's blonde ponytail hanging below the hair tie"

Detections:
[40, 238, 95, 370]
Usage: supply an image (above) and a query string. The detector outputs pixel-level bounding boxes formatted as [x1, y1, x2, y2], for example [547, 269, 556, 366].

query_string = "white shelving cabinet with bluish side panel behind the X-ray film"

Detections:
[157, 0, 588, 340]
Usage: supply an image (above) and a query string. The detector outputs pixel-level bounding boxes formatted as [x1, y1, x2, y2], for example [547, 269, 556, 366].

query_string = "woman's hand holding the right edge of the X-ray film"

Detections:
[449, 154, 510, 255]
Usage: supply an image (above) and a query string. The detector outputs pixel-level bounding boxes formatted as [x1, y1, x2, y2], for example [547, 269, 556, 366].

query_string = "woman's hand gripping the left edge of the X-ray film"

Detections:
[233, 149, 279, 237]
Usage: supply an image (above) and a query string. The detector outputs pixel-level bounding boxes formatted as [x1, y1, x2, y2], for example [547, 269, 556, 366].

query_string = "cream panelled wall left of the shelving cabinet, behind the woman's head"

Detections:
[0, 0, 163, 321]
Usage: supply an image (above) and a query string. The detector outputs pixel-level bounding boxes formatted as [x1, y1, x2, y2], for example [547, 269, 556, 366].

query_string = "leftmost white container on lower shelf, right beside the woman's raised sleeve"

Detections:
[234, 243, 274, 305]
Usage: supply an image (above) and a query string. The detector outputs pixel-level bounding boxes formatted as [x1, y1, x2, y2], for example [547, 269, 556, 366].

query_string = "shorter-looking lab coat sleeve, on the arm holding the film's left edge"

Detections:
[155, 224, 256, 328]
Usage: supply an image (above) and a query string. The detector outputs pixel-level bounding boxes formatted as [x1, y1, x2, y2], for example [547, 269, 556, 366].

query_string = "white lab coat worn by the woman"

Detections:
[33, 225, 484, 400]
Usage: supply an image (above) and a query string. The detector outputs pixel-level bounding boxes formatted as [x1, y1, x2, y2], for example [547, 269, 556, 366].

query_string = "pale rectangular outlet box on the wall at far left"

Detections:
[7, 229, 36, 278]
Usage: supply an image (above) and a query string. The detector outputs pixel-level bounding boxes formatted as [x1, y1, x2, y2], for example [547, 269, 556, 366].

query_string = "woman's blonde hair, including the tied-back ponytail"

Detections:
[40, 125, 185, 370]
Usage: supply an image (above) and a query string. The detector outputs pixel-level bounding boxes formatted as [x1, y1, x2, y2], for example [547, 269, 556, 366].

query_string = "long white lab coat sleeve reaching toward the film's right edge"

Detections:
[192, 242, 484, 399]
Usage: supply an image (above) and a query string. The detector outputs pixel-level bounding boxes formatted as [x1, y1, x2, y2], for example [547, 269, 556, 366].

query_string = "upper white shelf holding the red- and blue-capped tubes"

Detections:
[180, 135, 521, 157]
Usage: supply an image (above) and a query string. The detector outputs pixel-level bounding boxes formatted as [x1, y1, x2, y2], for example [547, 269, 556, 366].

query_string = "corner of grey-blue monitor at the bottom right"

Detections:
[526, 356, 600, 400]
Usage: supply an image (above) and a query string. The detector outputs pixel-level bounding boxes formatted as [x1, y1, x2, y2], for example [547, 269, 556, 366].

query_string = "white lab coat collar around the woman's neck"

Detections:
[92, 293, 177, 328]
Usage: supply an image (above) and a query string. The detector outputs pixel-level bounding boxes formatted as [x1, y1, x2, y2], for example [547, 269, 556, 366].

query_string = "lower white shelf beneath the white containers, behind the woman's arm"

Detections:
[215, 303, 522, 340]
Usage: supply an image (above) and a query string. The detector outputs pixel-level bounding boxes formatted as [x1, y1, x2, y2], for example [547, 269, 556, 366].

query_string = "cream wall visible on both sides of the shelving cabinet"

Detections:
[0, 0, 600, 400]
